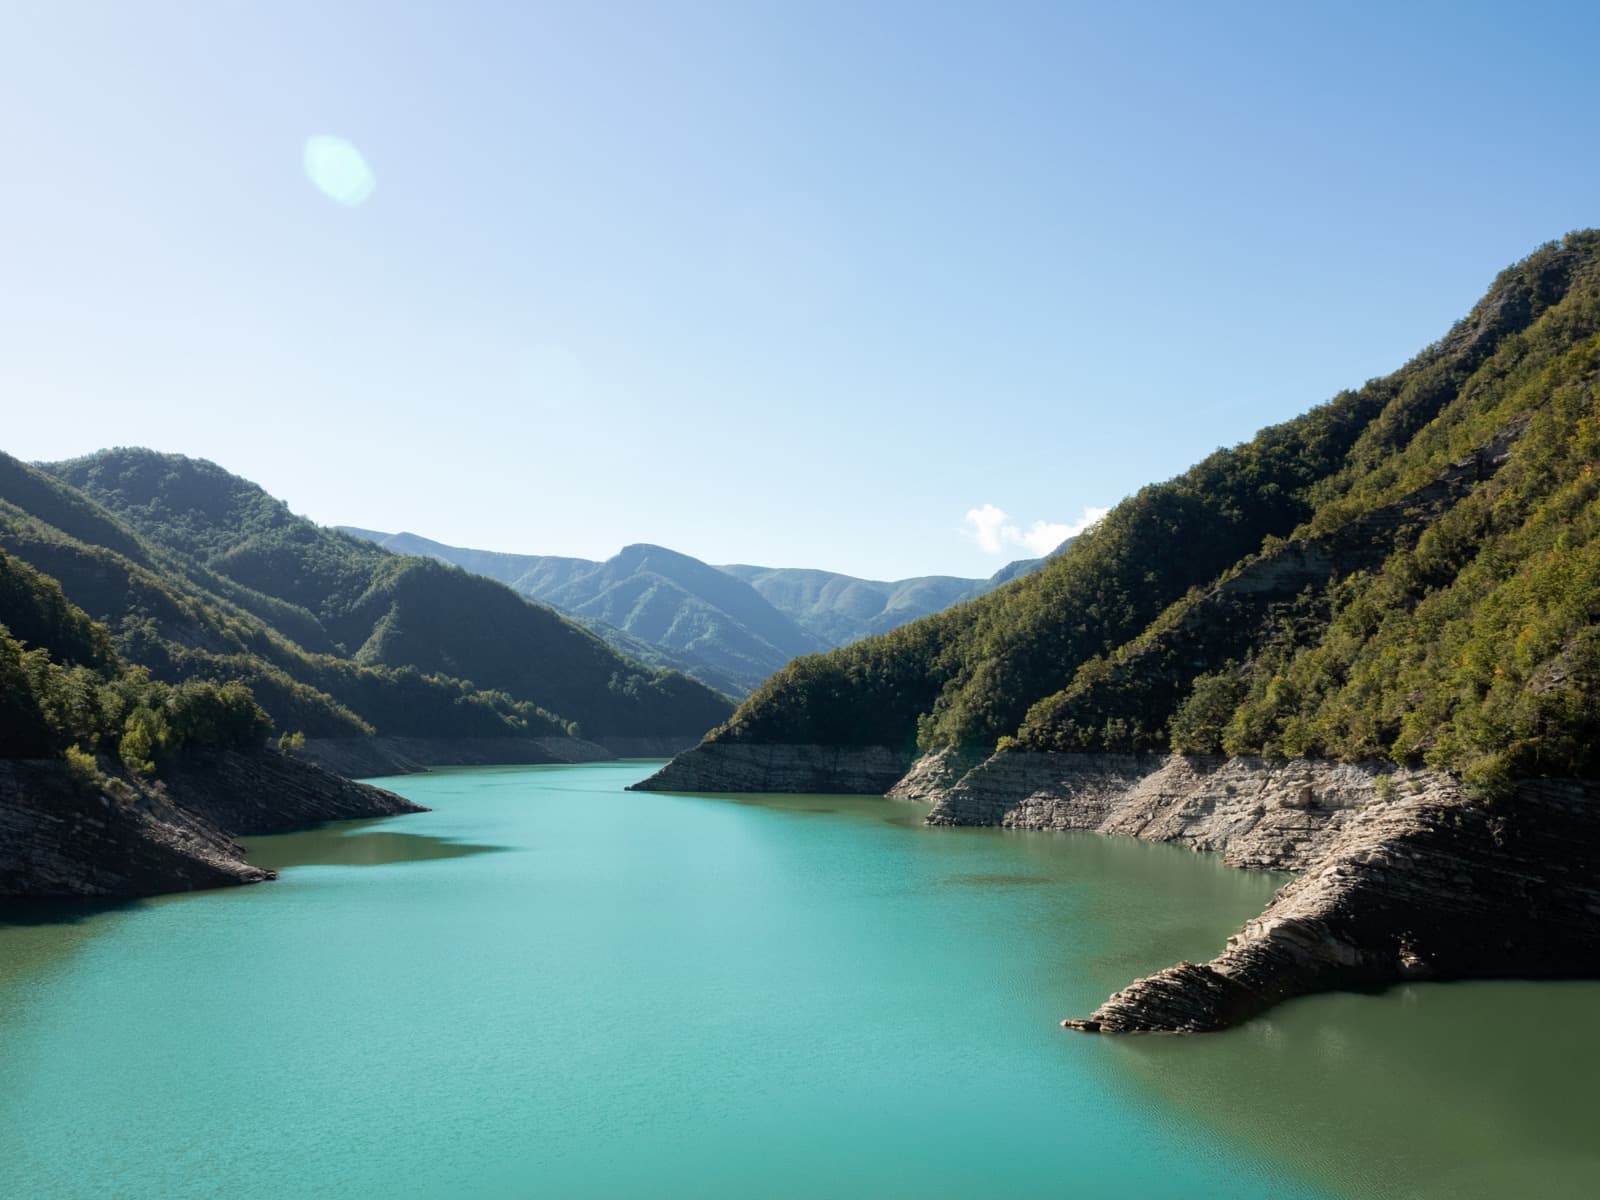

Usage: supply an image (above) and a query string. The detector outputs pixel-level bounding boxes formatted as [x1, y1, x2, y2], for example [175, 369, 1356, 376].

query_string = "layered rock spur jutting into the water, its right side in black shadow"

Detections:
[1062, 776, 1600, 1032]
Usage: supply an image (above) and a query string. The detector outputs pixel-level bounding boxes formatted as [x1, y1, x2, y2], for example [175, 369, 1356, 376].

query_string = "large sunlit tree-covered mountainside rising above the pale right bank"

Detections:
[656, 232, 1600, 784]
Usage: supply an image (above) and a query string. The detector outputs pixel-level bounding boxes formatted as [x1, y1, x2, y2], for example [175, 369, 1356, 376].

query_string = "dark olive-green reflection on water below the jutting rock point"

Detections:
[1109, 981, 1600, 1200]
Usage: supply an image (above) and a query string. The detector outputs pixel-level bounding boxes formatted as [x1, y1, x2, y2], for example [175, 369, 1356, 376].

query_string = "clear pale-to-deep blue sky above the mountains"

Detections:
[0, 0, 1600, 578]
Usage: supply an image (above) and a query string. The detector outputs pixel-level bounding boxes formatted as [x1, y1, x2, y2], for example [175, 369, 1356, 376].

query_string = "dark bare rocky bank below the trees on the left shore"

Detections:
[0, 750, 422, 896]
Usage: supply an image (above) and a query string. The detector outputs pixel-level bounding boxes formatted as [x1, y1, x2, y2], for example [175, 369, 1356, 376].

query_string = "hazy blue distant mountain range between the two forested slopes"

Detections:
[339, 525, 1064, 698]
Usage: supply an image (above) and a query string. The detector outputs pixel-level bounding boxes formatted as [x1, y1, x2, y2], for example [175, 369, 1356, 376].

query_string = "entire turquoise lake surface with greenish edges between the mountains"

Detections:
[0, 763, 1600, 1198]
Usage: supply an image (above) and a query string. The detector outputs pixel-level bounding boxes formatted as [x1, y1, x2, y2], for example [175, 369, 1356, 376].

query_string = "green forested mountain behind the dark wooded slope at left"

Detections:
[0, 450, 728, 752]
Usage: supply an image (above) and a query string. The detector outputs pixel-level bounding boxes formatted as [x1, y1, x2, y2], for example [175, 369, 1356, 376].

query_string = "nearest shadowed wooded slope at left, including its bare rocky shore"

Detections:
[0, 547, 432, 898]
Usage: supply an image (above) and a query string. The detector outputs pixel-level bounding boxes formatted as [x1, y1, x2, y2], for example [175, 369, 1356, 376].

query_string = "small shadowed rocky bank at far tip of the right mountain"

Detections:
[630, 742, 910, 795]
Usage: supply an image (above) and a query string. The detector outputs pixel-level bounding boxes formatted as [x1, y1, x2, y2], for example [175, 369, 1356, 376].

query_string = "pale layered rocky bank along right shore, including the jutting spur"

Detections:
[925, 752, 1600, 1032]
